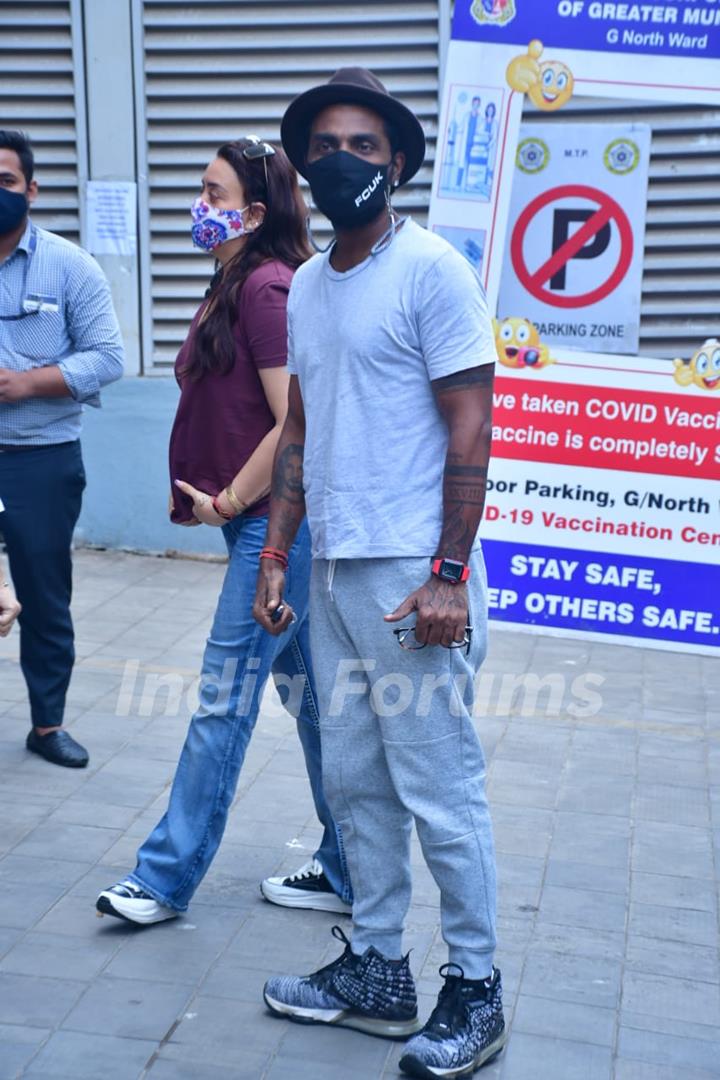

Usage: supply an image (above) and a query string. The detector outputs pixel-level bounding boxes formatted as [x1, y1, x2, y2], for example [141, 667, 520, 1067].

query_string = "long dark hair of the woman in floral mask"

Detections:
[182, 138, 312, 379]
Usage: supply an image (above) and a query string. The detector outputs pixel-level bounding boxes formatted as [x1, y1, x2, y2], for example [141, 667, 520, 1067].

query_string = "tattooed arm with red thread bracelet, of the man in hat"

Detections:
[253, 375, 305, 634]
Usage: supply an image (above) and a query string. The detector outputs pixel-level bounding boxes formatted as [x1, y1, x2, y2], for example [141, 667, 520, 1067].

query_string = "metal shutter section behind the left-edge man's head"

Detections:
[0, 0, 86, 241]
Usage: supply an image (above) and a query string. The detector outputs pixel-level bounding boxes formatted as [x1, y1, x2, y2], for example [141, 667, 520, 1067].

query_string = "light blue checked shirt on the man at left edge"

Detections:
[0, 219, 123, 445]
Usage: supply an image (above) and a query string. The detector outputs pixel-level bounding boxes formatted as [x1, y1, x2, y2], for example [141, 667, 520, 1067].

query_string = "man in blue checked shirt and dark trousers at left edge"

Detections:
[0, 131, 123, 768]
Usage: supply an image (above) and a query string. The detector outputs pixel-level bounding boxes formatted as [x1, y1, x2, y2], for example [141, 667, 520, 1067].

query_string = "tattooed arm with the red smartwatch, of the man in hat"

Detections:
[385, 364, 494, 647]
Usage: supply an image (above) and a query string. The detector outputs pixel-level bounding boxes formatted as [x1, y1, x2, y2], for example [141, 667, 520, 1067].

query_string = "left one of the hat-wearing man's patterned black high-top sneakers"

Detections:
[262, 927, 421, 1039]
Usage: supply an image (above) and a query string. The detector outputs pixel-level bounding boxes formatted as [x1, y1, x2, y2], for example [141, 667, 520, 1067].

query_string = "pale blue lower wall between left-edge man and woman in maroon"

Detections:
[76, 377, 226, 555]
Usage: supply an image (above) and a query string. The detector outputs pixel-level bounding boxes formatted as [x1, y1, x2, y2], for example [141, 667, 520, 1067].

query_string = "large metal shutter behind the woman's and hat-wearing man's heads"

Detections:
[134, 0, 442, 372]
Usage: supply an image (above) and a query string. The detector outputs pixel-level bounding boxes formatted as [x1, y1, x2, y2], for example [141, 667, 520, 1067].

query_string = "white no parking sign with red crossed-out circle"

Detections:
[498, 124, 650, 353]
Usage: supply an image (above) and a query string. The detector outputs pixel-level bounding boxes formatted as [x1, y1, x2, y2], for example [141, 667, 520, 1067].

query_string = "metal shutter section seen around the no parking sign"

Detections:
[524, 97, 720, 357]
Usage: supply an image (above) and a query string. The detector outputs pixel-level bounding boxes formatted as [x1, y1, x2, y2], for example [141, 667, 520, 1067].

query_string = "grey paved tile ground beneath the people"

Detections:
[0, 552, 720, 1080]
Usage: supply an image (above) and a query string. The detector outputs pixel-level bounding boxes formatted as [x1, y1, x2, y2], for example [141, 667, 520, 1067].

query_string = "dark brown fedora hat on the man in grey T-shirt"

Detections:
[280, 68, 425, 184]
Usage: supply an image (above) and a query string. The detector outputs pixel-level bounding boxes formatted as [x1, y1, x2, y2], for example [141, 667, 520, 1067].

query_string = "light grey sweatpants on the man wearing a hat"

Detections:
[310, 549, 495, 978]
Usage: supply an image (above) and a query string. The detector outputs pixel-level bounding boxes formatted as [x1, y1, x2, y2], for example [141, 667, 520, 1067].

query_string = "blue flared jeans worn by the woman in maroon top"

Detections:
[130, 517, 352, 912]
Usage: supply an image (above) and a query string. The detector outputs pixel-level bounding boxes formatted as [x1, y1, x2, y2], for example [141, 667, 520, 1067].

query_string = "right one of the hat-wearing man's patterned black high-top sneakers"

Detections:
[399, 963, 507, 1080]
